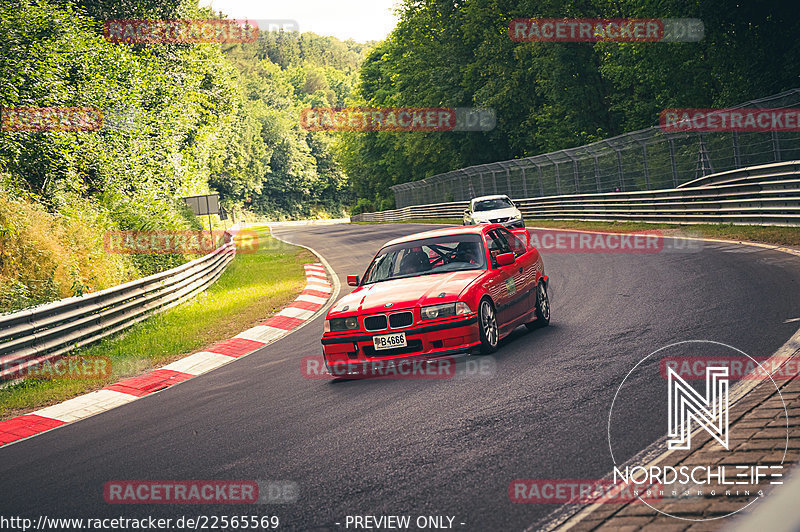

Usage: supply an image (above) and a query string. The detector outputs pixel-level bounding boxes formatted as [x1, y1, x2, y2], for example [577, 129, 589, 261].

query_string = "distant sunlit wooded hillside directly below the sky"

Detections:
[210, 32, 365, 219]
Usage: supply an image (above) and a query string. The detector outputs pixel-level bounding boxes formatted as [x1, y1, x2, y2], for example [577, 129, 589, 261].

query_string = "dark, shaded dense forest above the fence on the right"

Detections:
[338, 0, 800, 211]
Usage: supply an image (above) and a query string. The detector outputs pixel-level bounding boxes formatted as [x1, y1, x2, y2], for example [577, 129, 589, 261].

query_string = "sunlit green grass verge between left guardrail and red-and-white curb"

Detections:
[0, 227, 316, 420]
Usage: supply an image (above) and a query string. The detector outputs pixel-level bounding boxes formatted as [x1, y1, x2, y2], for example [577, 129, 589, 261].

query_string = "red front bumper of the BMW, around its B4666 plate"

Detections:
[322, 312, 480, 373]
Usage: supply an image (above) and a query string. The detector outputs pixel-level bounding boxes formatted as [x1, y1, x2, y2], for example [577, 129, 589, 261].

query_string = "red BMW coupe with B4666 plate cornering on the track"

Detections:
[322, 224, 550, 375]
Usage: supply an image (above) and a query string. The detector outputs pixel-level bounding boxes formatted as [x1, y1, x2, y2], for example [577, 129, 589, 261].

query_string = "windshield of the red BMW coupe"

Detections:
[364, 235, 486, 284]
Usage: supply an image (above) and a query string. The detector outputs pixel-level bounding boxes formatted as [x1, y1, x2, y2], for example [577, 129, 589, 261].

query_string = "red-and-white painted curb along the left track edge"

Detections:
[0, 263, 333, 446]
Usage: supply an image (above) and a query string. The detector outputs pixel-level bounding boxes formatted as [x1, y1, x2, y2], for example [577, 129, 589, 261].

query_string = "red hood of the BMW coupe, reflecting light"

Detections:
[328, 270, 486, 317]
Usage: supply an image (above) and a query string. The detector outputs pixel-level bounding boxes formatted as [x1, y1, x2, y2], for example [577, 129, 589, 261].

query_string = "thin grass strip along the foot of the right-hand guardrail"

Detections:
[354, 218, 800, 246]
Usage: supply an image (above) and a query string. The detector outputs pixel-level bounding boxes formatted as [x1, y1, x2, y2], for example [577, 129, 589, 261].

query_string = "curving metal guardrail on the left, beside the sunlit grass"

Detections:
[0, 233, 236, 378]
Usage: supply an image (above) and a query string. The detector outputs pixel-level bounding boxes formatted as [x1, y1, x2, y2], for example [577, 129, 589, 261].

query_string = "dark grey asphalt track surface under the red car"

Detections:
[0, 224, 800, 530]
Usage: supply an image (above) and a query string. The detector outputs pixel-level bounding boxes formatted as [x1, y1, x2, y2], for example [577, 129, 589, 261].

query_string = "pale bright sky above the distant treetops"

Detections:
[200, 0, 397, 42]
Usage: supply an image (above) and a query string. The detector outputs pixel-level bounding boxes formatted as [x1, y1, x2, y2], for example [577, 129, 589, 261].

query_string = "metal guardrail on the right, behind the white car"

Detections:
[351, 161, 800, 225]
